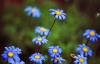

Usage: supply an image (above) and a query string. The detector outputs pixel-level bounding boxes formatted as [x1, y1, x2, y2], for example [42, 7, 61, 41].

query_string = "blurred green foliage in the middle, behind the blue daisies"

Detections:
[2, 0, 100, 64]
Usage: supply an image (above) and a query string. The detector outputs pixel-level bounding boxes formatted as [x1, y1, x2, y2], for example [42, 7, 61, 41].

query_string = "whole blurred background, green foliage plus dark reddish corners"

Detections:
[0, 0, 100, 64]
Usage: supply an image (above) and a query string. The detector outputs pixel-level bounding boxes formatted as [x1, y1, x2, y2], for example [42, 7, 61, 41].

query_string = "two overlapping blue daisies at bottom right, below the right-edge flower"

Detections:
[73, 44, 92, 64]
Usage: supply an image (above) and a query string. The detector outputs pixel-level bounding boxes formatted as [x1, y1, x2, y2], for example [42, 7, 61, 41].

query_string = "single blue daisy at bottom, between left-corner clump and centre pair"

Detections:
[29, 53, 45, 64]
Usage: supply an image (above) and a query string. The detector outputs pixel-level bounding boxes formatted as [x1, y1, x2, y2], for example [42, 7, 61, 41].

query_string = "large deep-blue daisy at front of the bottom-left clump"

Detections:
[1, 46, 20, 63]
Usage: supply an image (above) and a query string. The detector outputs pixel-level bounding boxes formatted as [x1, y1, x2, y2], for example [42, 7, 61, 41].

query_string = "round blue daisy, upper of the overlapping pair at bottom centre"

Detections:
[48, 46, 62, 57]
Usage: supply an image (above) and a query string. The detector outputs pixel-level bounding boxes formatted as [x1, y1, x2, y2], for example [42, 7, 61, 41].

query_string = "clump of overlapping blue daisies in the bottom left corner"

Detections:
[1, 46, 25, 64]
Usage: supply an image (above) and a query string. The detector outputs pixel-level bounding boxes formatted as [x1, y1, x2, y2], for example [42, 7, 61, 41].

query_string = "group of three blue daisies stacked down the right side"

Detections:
[73, 29, 100, 64]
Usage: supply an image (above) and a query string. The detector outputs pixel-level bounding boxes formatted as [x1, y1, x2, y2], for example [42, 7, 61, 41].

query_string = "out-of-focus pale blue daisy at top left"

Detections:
[24, 6, 41, 18]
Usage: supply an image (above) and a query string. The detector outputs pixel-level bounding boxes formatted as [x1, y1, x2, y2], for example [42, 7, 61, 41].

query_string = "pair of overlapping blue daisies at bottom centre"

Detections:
[48, 46, 66, 64]
